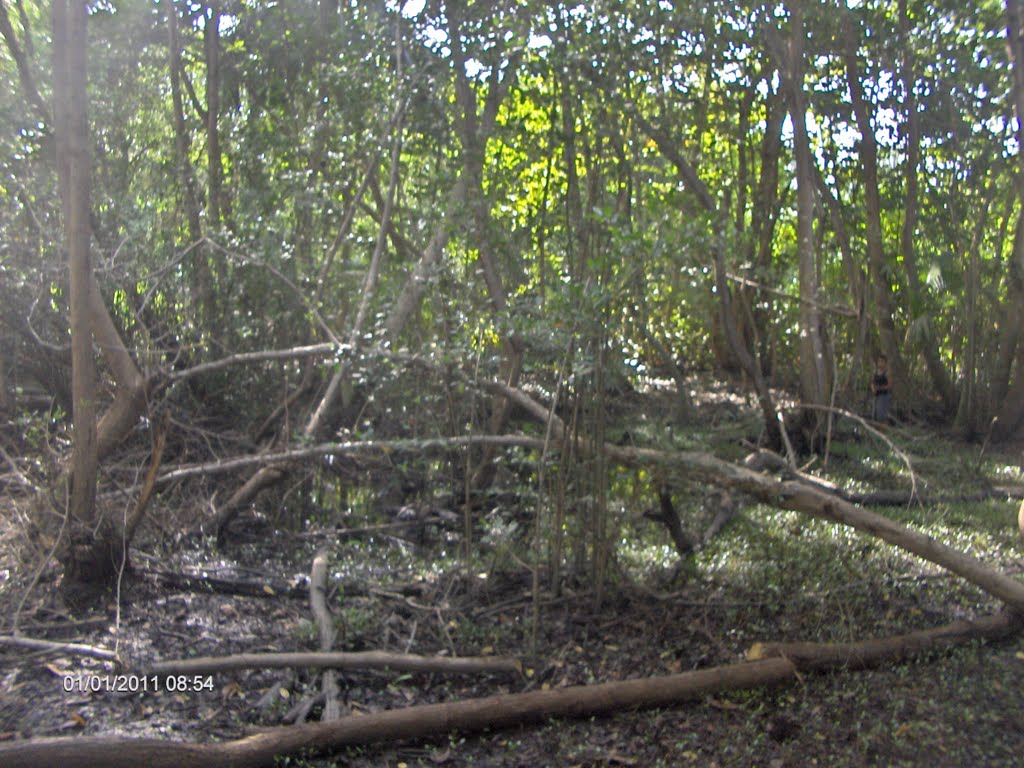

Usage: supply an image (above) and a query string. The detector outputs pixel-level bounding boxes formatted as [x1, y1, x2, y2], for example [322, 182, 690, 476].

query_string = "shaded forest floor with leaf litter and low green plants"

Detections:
[0, 382, 1024, 768]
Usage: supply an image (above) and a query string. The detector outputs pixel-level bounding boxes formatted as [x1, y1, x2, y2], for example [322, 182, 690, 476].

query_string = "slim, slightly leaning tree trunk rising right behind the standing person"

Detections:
[844, 22, 911, 408]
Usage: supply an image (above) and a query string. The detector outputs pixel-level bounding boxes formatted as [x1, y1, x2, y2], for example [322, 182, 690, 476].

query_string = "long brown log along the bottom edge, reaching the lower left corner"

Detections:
[0, 658, 797, 768]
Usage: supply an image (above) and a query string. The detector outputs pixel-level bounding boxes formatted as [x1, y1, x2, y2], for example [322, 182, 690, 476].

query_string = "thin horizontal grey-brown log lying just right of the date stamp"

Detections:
[148, 650, 522, 675]
